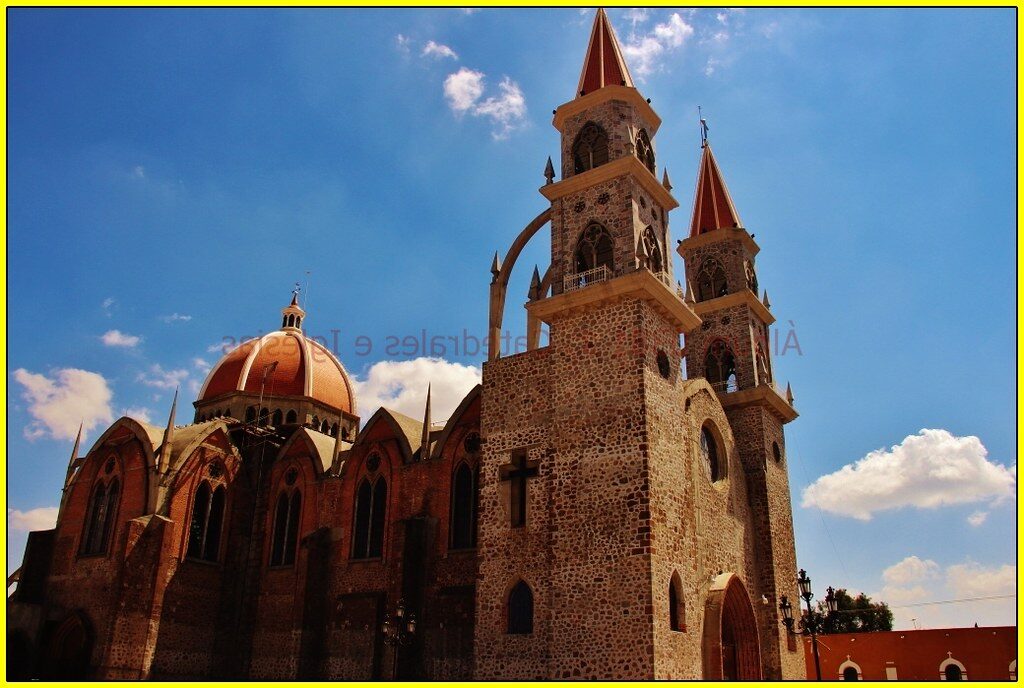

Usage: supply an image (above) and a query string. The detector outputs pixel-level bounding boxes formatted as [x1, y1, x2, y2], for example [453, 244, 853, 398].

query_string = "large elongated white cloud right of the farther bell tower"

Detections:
[802, 429, 1016, 521]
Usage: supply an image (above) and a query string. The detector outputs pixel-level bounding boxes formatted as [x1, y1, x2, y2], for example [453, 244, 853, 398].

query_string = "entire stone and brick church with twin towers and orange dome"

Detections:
[8, 10, 804, 680]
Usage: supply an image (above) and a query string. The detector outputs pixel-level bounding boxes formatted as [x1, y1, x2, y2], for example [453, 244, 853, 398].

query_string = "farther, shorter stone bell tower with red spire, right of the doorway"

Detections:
[678, 139, 803, 679]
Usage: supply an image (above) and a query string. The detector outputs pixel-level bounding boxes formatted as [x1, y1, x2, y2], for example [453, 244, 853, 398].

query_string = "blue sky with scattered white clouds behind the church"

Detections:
[7, 8, 1017, 627]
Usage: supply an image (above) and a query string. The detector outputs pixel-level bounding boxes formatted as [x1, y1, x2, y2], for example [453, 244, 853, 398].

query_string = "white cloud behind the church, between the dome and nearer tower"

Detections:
[352, 357, 480, 422]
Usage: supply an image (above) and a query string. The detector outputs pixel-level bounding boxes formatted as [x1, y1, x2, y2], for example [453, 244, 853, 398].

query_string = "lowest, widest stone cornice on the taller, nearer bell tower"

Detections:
[526, 269, 700, 334]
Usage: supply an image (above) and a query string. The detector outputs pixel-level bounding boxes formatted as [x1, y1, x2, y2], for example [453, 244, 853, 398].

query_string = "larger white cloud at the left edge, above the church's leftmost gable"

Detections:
[14, 368, 114, 440]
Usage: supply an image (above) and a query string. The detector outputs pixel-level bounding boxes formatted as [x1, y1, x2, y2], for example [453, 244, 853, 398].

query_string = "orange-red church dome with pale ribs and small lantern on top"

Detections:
[197, 298, 355, 414]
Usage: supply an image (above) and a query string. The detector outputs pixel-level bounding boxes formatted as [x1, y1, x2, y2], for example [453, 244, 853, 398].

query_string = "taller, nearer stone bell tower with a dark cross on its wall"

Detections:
[474, 10, 699, 680]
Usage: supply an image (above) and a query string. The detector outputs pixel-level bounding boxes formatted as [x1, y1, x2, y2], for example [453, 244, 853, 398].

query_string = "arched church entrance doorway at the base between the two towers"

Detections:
[703, 573, 761, 681]
